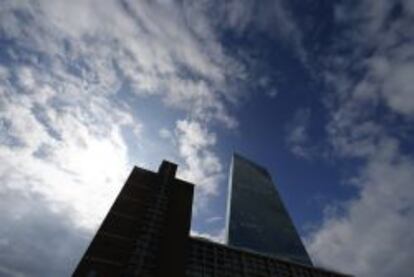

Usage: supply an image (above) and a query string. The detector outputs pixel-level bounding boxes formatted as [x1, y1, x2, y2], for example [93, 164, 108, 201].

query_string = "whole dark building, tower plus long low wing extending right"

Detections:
[73, 157, 345, 277]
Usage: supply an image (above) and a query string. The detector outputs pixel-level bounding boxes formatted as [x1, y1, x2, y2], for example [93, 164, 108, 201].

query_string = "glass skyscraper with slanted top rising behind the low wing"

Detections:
[226, 154, 312, 265]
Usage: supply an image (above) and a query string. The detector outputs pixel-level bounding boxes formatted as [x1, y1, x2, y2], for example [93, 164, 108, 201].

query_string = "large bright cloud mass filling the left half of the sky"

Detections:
[0, 0, 245, 276]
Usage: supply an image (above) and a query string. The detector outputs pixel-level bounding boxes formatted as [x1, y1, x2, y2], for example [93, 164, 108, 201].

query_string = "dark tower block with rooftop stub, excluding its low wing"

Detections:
[73, 162, 194, 277]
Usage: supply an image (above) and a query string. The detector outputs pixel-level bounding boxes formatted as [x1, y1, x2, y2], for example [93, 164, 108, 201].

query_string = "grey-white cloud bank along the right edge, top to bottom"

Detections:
[307, 0, 414, 276]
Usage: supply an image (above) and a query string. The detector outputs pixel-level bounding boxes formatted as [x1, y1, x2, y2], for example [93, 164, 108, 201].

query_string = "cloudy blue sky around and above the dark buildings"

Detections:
[0, 0, 414, 277]
